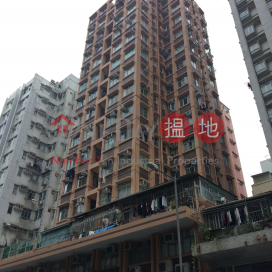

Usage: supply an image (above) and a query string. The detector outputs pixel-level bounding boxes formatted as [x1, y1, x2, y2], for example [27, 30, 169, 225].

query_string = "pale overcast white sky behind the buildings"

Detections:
[0, 0, 268, 195]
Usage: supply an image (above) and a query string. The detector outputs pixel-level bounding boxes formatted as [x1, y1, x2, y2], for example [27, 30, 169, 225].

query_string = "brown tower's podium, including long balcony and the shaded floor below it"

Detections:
[0, 174, 235, 272]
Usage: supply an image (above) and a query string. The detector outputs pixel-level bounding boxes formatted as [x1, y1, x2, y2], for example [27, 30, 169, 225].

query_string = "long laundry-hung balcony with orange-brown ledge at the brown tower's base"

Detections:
[0, 174, 235, 272]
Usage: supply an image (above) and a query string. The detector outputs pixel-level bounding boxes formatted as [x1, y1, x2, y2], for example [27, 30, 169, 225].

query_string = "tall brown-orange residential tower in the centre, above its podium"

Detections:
[56, 0, 245, 225]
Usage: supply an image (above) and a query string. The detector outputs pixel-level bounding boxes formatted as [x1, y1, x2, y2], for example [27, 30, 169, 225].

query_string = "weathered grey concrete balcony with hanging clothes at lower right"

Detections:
[193, 192, 272, 271]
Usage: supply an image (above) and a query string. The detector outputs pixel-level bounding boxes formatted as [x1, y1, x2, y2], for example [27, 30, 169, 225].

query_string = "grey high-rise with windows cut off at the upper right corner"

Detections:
[229, 0, 272, 158]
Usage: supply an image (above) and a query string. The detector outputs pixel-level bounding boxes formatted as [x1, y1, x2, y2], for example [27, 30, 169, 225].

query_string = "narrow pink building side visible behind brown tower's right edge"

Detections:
[220, 102, 247, 198]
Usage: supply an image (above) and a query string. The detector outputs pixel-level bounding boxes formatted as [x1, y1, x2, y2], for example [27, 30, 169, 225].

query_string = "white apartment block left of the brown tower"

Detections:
[0, 74, 78, 246]
